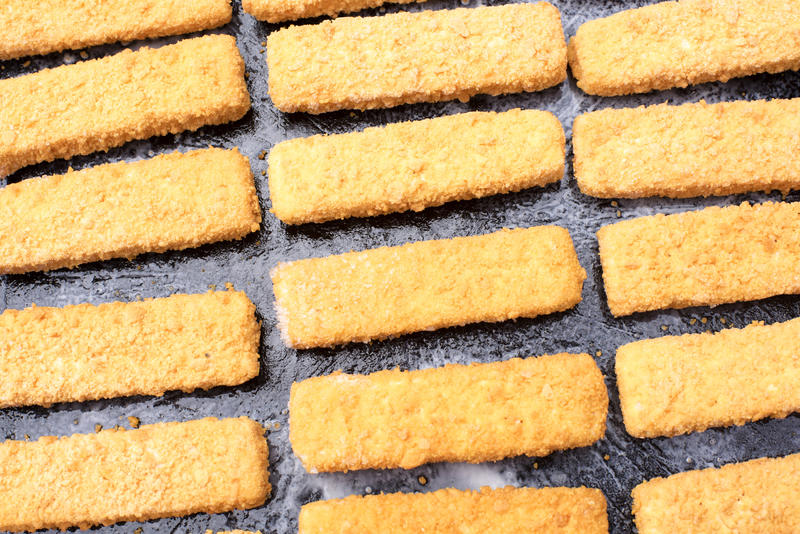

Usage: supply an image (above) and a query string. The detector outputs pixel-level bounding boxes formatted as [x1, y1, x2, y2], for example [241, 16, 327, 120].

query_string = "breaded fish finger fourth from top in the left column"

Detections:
[0, 291, 260, 408]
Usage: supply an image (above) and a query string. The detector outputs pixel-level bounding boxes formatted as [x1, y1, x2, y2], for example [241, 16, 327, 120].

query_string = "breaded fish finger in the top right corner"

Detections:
[569, 0, 800, 96]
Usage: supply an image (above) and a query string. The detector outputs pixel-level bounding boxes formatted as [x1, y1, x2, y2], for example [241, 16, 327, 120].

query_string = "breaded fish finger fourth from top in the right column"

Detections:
[616, 319, 800, 438]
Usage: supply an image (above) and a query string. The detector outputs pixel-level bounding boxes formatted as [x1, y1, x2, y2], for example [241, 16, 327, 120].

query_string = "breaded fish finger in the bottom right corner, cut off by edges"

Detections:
[633, 454, 800, 534]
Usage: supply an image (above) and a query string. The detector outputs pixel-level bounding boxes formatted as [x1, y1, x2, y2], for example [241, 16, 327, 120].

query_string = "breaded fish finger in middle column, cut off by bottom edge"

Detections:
[299, 486, 608, 534]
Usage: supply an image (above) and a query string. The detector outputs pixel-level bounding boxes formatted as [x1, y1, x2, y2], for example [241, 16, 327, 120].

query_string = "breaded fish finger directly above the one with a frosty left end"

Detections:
[269, 109, 565, 224]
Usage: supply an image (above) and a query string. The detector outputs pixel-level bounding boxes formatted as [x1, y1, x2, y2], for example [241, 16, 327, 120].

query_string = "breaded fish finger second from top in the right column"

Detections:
[573, 98, 800, 198]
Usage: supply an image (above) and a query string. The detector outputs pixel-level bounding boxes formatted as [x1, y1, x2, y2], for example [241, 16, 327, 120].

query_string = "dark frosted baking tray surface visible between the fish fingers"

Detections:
[0, 0, 800, 533]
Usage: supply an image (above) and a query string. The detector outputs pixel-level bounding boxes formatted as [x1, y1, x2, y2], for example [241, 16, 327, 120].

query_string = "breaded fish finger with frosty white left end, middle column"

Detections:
[272, 226, 586, 349]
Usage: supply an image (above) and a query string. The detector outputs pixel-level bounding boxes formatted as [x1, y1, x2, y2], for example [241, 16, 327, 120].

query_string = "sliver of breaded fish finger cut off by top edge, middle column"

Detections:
[242, 0, 425, 23]
